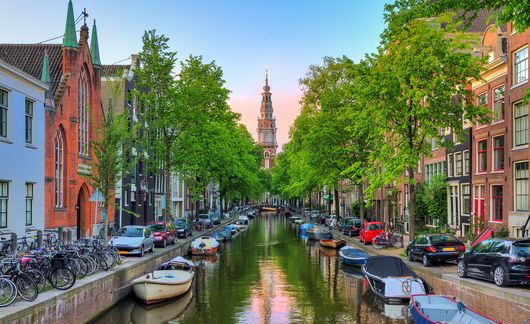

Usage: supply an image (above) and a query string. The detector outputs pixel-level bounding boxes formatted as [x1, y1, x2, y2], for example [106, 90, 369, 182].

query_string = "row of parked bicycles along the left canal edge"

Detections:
[0, 234, 120, 307]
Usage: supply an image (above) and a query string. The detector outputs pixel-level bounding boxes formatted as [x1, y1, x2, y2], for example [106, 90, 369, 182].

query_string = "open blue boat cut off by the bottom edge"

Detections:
[409, 295, 500, 324]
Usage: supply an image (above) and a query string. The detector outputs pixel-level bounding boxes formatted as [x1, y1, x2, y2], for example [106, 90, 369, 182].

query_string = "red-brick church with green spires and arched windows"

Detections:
[0, 1, 107, 238]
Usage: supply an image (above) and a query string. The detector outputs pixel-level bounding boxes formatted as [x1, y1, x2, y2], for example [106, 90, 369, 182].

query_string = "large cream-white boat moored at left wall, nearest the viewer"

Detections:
[132, 257, 195, 304]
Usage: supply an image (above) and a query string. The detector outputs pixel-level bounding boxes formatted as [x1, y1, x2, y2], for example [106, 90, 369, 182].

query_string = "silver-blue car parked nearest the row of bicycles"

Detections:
[110, 225, 155, 256]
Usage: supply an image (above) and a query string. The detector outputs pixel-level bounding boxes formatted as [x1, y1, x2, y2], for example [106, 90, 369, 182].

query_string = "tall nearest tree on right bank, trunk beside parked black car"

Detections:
[362, 17, 488, 239]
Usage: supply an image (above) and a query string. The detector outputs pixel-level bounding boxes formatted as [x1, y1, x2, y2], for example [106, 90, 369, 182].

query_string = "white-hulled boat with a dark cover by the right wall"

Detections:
[362, 255, 426, 303]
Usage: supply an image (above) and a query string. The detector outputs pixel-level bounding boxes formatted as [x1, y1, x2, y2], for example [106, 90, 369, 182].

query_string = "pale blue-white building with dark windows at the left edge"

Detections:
[0, 60, 48, 237]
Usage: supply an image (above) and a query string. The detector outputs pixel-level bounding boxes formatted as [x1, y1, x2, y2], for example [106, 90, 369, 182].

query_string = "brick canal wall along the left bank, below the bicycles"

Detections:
[0, 218, 235, 324]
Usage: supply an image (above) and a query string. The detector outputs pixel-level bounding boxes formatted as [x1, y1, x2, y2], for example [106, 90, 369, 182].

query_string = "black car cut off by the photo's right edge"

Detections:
[456, 239, 530, 286]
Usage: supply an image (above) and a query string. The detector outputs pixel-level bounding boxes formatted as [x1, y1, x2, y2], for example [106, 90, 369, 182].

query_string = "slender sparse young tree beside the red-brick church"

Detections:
[88, 84, 135, 246]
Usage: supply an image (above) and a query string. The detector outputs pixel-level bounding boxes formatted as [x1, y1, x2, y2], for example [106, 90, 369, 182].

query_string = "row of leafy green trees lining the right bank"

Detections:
[272, 0, 517, 238]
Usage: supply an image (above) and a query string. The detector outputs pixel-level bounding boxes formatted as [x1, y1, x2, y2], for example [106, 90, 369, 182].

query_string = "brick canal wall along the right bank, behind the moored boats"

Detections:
[333, 231, 530, 324]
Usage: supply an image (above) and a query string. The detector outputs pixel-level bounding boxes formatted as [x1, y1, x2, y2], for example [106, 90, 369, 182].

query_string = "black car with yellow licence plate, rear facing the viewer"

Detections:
[407, 234, 466, 267]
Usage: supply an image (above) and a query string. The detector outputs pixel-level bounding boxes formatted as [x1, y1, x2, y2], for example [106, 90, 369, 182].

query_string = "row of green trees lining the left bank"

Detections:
[91, 30, 264, 244]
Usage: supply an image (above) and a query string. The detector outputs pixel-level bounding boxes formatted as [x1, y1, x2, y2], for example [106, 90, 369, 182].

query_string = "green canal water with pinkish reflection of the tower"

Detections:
[95, 213, 406, 324]
